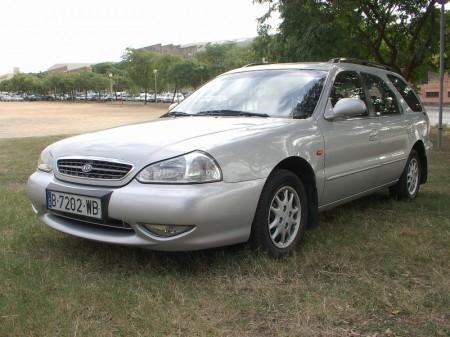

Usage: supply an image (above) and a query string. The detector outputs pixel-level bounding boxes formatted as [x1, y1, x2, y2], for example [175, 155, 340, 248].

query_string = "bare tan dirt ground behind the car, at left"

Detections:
[0, 102, 169, 138]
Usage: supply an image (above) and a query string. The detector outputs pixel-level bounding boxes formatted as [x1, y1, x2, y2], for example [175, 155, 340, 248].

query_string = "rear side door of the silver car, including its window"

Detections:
[361, 73, 410, 184]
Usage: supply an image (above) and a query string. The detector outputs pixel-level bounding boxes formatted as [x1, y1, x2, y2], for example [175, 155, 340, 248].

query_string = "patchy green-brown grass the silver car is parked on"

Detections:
[0, 130, 450, 337]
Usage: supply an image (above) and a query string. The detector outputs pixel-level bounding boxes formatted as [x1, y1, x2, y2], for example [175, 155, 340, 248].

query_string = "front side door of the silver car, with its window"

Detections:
[320, 71, 380, 205]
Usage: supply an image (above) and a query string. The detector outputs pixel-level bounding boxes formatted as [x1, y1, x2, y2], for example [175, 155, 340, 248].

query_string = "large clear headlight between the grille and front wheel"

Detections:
[136, 151, 222, 184]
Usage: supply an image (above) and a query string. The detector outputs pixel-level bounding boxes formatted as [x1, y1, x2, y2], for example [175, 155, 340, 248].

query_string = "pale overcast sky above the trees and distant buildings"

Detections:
[0, 0, 279, 75]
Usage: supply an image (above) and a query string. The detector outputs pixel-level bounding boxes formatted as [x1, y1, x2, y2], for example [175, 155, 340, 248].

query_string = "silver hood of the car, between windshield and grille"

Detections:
[50, 117, 288, 167]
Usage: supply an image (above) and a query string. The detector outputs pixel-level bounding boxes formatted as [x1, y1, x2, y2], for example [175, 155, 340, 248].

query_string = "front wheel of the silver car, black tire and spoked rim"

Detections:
[251, 169, 308, 258]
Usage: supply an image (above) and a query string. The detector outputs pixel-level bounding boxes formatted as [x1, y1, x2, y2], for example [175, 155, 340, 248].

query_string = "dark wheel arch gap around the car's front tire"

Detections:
[270, 156, 319, 228]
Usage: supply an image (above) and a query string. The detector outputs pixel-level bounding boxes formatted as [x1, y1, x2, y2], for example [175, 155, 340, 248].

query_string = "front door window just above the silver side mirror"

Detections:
[330, 71, 365, 110]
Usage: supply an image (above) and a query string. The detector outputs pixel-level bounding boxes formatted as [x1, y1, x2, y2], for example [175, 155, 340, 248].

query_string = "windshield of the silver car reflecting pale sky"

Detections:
[166, 69, 327, 118]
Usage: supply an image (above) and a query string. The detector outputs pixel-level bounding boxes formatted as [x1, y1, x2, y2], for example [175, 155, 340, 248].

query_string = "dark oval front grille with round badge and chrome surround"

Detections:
[57, 158, 133, 180]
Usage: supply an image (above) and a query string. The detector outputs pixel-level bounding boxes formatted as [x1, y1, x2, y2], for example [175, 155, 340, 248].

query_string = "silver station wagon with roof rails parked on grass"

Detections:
[28, 59, 431, 256]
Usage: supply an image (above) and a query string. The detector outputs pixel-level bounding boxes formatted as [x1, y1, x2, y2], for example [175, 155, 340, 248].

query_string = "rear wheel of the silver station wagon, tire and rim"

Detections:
[389, 150, 422, 200]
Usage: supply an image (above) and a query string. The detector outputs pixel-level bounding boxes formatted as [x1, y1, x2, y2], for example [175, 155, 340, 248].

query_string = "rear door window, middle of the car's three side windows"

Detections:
[362, 73, 400, 116]
